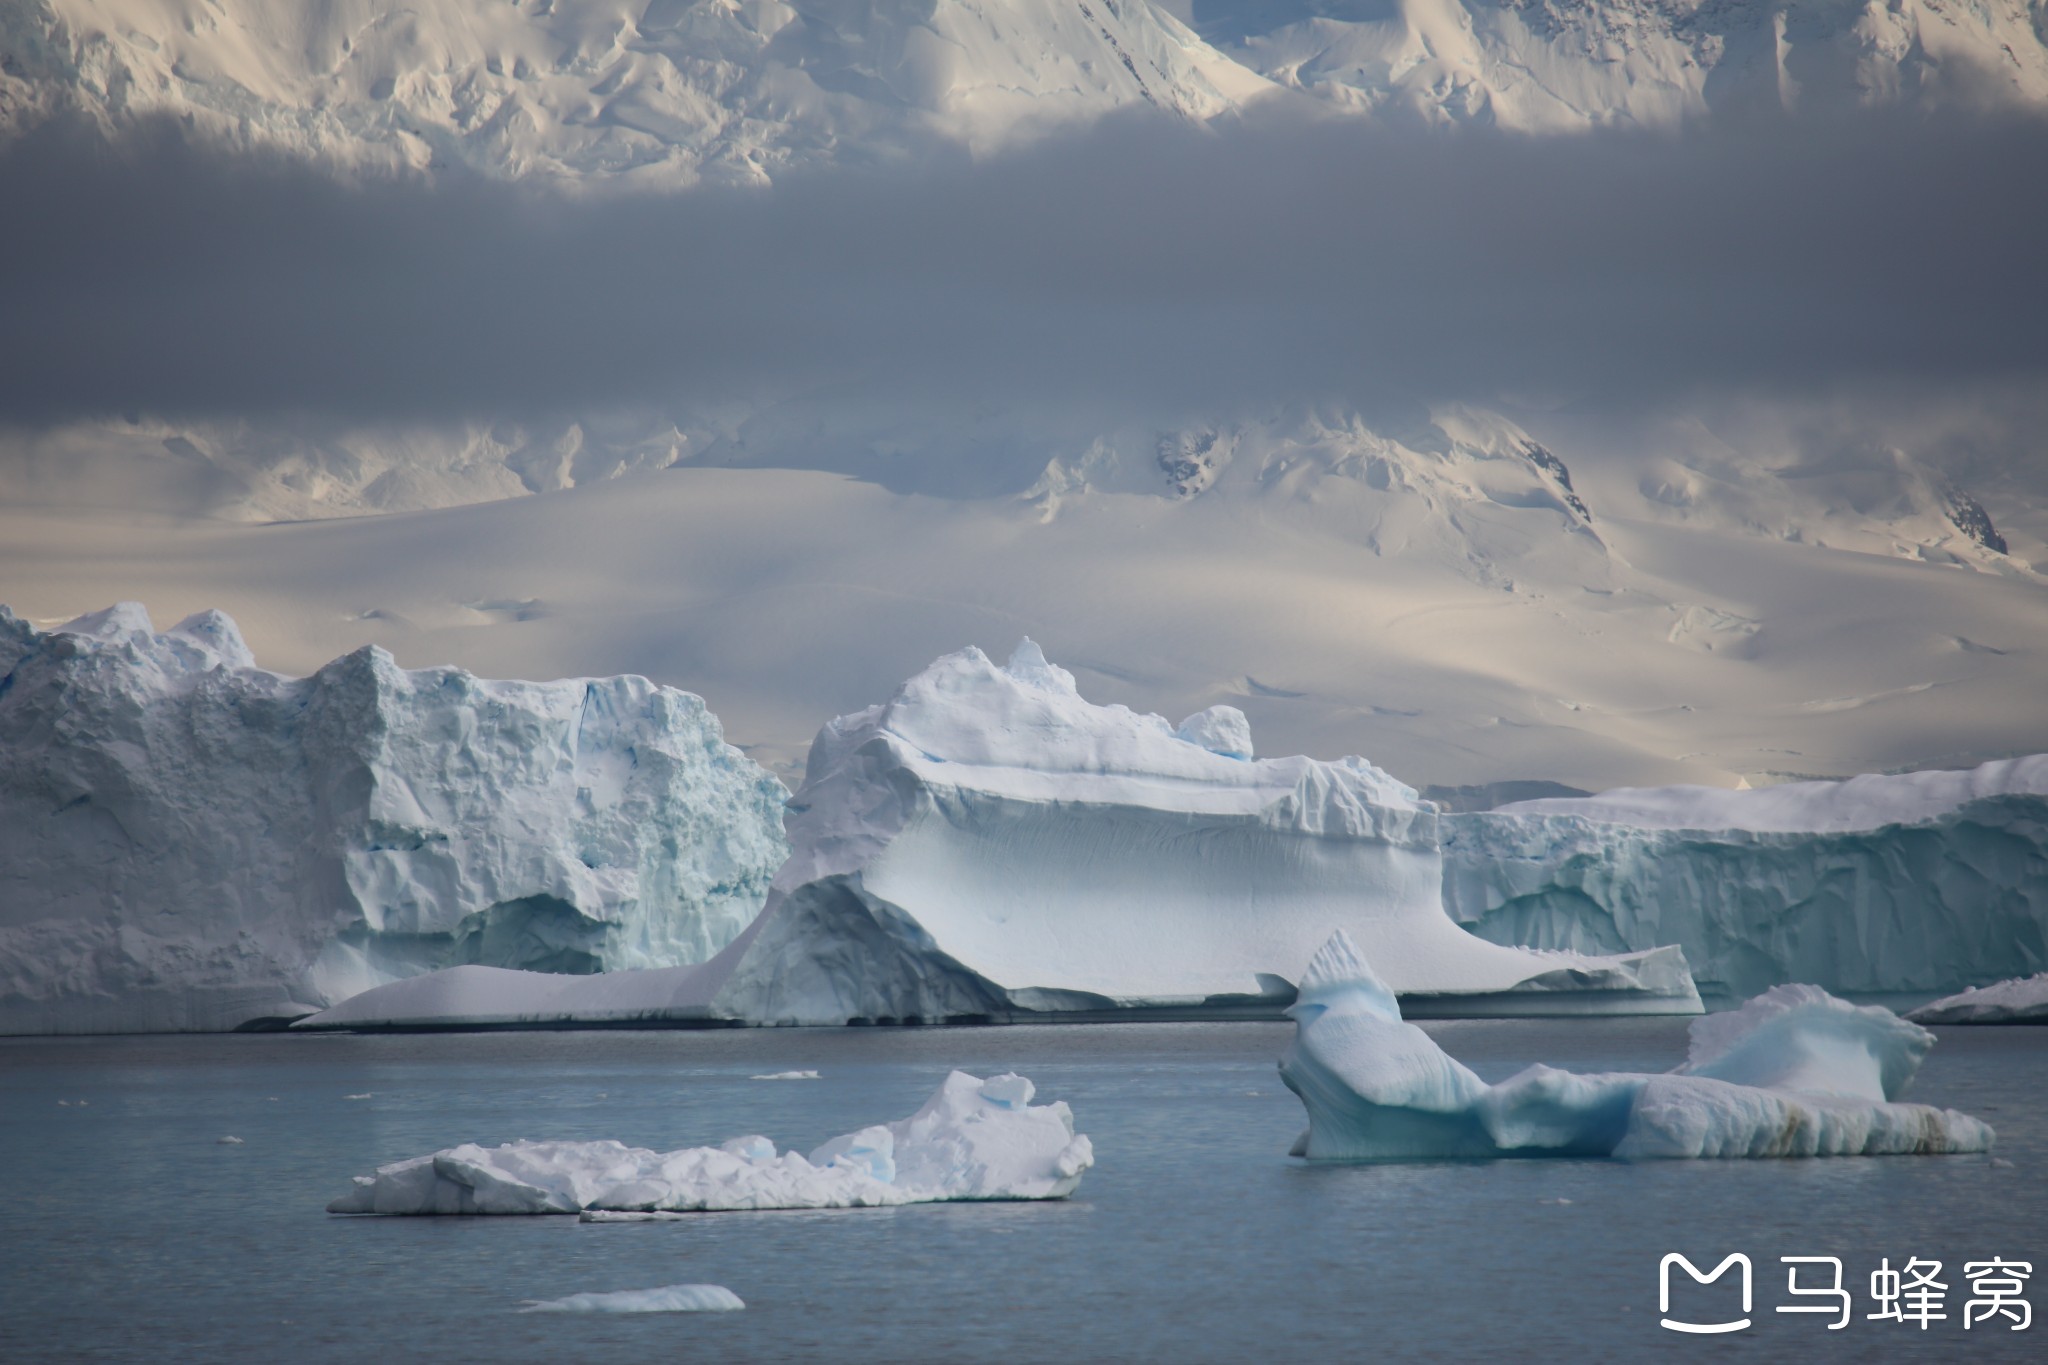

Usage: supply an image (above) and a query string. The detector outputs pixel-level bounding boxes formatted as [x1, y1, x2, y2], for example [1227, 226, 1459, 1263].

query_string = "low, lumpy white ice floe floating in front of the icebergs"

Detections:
[328, 1070, 1096, 1216]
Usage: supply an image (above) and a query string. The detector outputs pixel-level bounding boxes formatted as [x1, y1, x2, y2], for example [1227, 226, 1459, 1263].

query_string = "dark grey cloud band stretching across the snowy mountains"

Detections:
[0, 106, 2048, 422]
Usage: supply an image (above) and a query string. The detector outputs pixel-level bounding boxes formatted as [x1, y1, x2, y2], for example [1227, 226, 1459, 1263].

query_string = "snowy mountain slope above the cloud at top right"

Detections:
[1194, 0, 2048, 133]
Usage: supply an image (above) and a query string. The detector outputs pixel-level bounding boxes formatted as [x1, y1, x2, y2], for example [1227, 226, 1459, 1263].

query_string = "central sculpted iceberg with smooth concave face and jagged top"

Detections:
[292, 641, 1700, 1027]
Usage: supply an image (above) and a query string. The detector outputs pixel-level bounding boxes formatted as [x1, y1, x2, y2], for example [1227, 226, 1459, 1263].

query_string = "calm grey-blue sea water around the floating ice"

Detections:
[0, 1019, 2048, 1365]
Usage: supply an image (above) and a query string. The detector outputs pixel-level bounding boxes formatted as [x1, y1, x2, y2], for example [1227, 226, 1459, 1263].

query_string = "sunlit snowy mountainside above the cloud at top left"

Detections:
[0, 0, 1270, 188]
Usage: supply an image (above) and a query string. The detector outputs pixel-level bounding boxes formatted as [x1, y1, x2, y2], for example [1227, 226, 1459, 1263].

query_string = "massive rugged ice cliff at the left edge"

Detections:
[0, 602, 786, 1033]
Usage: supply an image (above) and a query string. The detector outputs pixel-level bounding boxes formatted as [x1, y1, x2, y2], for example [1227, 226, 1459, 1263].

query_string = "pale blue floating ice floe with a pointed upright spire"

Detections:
[1280, 931, 1993, 1160]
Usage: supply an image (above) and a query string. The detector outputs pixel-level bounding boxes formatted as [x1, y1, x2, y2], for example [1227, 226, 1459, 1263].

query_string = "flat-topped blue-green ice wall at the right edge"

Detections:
[1444, 755, 2048, 999]
